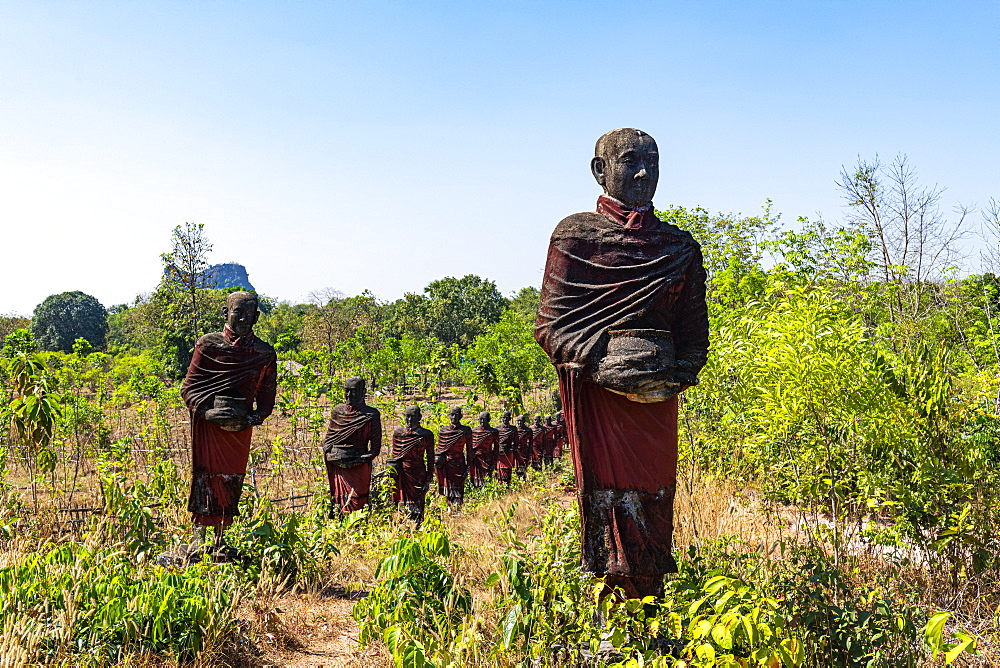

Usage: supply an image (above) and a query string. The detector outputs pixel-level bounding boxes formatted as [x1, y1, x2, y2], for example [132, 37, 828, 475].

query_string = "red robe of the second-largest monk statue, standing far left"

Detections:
[181, 325, 278, 527]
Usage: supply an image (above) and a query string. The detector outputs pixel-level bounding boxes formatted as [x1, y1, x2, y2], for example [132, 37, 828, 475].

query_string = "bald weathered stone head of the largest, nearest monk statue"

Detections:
[590, 128, 660, 209]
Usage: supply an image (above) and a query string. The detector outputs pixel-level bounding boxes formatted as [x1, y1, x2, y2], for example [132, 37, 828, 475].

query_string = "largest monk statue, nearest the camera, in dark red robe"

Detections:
[535, 128, 708, 597]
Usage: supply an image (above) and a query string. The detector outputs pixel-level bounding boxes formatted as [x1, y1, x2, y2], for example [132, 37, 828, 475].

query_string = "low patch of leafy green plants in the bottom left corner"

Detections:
[0, 540, 236, 665]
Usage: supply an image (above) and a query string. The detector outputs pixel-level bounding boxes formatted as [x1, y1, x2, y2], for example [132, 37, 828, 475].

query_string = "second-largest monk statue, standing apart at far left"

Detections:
[181, 292, 278, 557]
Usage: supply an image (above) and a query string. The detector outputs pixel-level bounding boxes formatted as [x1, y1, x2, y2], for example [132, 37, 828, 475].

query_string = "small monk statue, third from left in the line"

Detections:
[386, 406, 434, 524]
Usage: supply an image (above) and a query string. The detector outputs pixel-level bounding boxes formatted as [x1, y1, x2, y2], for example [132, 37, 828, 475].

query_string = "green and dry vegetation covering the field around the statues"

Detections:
[0, 158, 1000, 667]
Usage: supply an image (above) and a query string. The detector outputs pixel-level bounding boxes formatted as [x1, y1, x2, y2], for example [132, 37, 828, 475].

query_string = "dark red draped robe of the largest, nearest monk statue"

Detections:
[535, 197, 708, 578]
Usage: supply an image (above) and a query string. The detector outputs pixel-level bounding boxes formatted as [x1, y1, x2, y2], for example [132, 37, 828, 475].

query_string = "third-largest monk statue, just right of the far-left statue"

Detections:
[323, 376, 382, 517]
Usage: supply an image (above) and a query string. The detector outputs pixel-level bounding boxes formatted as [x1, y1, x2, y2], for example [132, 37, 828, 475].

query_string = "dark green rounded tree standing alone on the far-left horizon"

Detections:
[31, 290, 108, 353]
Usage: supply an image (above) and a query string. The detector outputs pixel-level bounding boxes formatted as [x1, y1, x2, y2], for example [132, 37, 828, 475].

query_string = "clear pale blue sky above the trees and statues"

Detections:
[0, 0, 1000, 314]
